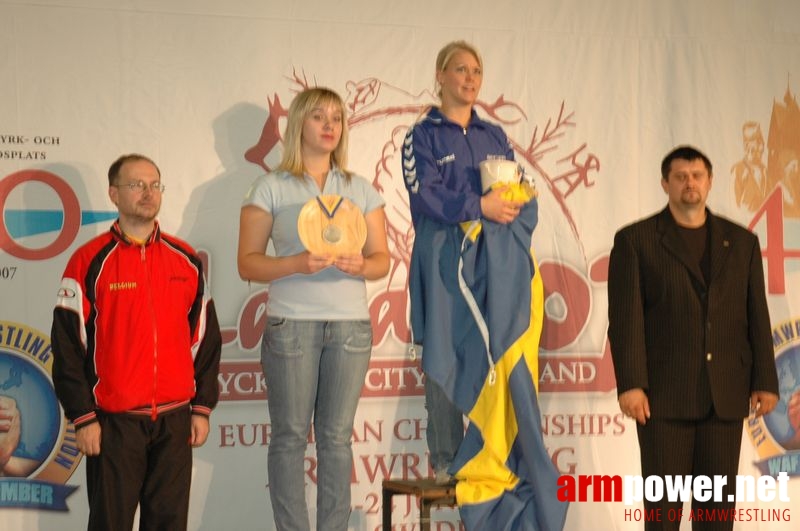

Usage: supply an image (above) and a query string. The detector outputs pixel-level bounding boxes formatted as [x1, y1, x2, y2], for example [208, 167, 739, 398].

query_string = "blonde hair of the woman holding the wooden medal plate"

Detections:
[278, 87, 350, 179]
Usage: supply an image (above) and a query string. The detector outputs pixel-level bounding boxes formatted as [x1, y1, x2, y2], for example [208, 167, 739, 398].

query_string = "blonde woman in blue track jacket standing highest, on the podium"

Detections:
[403, 41, 522, 484]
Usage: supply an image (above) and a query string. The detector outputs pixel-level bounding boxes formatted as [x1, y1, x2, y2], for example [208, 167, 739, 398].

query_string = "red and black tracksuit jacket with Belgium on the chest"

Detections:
[51, 223, 222, 427]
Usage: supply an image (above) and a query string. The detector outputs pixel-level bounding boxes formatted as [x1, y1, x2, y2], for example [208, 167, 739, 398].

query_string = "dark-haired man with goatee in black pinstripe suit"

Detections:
[608, 146, 778, 530]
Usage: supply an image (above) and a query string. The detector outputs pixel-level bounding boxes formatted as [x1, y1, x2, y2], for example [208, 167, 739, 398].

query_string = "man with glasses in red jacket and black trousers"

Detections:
[51, 155, 222, 530]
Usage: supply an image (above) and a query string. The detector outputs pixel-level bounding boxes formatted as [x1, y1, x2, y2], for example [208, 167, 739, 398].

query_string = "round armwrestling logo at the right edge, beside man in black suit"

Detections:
[747, 318, 800, 476]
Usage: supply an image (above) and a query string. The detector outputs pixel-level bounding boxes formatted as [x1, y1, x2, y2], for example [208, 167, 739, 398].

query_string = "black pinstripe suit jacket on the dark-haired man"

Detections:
[608, 208, 778, 420]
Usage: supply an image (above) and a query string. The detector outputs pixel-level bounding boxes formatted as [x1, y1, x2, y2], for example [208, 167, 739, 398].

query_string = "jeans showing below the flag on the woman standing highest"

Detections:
[425, 377, 464, 473]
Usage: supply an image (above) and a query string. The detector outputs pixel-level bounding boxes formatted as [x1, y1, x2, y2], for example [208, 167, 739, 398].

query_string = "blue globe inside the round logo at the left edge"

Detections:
[0, 350, 61, 463]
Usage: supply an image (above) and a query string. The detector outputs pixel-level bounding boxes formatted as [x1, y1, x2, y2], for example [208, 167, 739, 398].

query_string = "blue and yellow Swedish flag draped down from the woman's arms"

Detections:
[412, 194, 567, 531]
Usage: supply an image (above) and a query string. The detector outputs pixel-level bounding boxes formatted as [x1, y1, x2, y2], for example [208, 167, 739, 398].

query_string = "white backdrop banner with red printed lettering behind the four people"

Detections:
[0, 0, 800, 531]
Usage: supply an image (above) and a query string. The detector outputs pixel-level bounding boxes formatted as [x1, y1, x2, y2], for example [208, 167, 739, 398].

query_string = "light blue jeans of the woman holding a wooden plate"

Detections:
[261, 317, 372, 531]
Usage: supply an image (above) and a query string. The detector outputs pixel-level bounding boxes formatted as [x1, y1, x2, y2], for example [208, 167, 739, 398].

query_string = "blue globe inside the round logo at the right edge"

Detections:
[764, 345, 800, 450]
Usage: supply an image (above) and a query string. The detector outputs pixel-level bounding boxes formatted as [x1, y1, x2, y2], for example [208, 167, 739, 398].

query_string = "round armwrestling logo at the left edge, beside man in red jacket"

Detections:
[0, 321, 81, 511]
